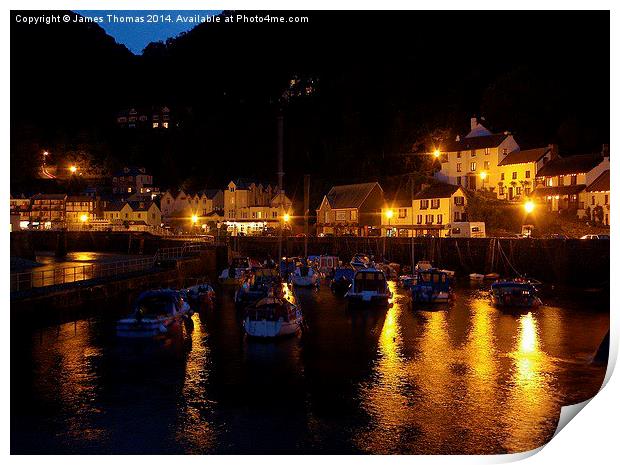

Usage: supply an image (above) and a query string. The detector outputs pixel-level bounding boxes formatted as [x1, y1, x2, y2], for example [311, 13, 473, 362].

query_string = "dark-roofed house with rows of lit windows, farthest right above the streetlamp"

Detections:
[532, 145, 609, 217]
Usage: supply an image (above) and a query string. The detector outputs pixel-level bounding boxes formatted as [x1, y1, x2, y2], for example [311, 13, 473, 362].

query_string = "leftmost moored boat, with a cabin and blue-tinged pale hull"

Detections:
[116, 289, 191, 338]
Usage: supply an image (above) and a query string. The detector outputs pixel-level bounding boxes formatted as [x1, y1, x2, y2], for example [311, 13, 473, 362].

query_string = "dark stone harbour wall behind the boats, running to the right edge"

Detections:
[230, 237, 610, 287]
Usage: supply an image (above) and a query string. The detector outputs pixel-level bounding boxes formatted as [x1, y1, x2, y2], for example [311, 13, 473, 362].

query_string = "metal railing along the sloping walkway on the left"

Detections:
[11, 243, 206, 292]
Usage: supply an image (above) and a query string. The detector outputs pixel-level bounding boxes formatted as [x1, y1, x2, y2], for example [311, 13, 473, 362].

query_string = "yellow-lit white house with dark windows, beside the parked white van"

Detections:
[381, 183, 467, 237]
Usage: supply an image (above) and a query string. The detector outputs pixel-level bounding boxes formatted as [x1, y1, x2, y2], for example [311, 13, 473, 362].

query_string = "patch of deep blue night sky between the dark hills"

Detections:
[75, 10, 221, 55]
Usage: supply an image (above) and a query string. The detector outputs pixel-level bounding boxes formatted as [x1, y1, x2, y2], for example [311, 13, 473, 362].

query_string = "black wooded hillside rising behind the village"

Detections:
[11, 12, 609, 207]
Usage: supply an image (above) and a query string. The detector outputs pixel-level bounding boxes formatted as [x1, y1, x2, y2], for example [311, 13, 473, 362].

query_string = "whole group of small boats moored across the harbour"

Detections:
[117, 254, 542, 338]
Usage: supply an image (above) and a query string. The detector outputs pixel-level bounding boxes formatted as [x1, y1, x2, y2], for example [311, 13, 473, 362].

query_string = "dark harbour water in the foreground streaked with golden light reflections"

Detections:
[11, 283, 609, 454]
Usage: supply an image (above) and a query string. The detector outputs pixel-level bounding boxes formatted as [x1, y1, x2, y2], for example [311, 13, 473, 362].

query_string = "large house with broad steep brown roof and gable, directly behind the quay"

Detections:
[316, 182, 385, 236]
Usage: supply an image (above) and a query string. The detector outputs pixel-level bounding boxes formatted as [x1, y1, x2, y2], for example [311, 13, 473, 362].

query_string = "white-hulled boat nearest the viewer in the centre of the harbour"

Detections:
[243, 295, 302, 338]
